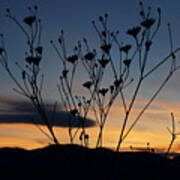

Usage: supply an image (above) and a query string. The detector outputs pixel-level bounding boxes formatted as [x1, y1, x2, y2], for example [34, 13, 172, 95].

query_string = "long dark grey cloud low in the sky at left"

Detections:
[0, 97, 95, 127]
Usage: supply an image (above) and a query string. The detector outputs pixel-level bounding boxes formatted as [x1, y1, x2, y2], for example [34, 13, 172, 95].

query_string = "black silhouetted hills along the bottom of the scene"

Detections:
[0, 145, 180, 180]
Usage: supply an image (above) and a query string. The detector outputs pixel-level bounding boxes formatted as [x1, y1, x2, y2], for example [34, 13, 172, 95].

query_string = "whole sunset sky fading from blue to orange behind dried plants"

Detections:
[0, 0, 180, 151]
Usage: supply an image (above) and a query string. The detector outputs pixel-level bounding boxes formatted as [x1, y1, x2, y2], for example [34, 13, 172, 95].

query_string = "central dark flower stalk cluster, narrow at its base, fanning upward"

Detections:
[84, 14, 132, 147]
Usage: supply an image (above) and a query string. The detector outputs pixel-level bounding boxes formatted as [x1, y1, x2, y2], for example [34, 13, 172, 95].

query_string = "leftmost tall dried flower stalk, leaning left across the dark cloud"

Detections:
[0, 6, 58, 144]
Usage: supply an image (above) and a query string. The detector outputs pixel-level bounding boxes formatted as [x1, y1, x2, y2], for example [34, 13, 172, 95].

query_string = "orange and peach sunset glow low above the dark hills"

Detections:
[0, 94, 180, 152]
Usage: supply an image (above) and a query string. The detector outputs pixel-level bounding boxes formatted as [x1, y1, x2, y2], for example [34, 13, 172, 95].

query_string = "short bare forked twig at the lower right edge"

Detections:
[166, 113, 180, 156]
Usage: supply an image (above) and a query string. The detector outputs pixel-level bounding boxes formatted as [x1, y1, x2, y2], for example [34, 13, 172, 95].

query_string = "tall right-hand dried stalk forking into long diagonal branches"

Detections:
[116, 2, 180, 151]
